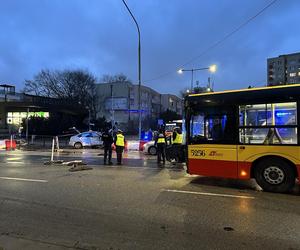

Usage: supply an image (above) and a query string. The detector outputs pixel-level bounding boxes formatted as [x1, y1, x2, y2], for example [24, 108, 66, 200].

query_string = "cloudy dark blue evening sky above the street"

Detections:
[0, 0, 300, 94]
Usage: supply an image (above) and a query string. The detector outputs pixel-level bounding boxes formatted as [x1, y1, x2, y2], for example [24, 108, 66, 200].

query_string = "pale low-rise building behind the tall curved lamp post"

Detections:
[96, 82, 182, 132]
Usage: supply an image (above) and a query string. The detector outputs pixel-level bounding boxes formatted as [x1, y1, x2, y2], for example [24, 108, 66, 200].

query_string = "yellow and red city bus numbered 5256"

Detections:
[184, 84, 300, 193]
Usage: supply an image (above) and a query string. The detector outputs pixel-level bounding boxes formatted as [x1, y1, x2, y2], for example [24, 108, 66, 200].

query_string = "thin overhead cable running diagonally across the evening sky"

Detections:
[145, 0, 278, 83]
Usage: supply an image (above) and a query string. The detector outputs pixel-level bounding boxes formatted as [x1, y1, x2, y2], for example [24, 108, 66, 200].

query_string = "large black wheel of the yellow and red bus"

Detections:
[254, 158, 296, 193]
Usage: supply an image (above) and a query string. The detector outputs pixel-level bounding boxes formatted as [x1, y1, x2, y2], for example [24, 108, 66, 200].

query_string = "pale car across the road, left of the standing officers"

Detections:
[69, 131, 103, 149]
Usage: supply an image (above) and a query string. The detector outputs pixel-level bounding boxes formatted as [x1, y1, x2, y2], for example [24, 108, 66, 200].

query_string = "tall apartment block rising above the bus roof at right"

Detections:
[267, 53, 300, 86]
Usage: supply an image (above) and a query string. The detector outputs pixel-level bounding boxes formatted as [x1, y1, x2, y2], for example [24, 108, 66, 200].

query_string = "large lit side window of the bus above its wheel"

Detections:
[239, 102, 297, 144]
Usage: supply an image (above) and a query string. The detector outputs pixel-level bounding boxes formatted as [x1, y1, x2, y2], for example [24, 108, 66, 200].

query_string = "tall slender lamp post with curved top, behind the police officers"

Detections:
[122, 0, 142, 140]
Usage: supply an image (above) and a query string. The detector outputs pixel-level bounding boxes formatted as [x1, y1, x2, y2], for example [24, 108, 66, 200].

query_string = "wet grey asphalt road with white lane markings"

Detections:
[0, 150, 300, 250]
